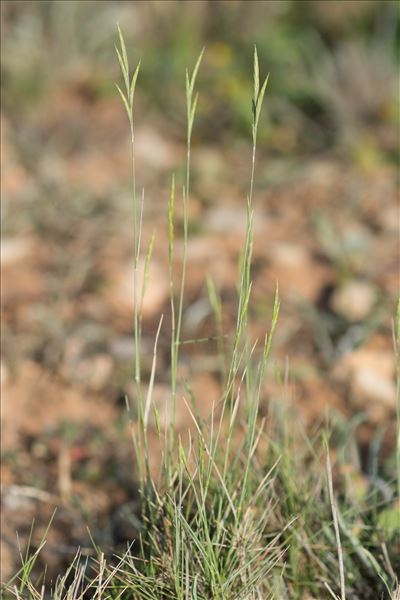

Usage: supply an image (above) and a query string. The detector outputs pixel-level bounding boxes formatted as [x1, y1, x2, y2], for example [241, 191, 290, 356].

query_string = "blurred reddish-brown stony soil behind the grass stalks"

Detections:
[1, 84, 398, 578]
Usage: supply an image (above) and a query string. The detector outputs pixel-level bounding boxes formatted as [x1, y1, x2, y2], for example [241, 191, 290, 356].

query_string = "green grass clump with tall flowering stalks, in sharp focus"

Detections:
[3, 32, 400, 600]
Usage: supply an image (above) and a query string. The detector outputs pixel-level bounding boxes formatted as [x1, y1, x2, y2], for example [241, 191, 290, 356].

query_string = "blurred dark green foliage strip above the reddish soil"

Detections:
[2, 0, 399, 155]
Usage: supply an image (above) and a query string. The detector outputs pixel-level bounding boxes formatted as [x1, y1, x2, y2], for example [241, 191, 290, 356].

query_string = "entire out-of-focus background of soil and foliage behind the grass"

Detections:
[1, 0, 400, 578]
